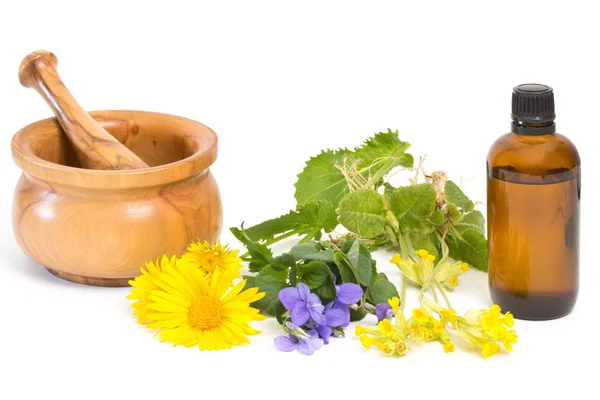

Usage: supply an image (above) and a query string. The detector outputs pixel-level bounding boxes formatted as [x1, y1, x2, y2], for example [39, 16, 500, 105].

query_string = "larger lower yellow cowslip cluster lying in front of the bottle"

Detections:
[356, 298, 517, 358]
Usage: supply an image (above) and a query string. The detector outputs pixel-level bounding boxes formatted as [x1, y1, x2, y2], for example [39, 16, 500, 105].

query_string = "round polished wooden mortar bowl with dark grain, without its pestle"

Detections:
[12, 111, 223, 286]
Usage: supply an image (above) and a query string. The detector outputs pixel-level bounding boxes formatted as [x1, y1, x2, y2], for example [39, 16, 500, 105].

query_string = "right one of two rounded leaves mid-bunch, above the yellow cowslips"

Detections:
[390, 183, 437, 232]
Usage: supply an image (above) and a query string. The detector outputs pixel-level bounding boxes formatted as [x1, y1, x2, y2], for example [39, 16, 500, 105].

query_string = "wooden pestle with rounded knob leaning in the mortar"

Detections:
[19, 50, 148, 169]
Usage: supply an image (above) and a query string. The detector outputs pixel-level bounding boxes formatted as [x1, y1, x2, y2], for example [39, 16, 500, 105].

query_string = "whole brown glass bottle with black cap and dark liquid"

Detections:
[487, 84, 581, 320]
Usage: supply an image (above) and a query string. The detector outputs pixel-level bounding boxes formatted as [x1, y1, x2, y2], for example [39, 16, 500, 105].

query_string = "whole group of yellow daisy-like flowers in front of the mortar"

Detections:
[127, 242, 265, 350]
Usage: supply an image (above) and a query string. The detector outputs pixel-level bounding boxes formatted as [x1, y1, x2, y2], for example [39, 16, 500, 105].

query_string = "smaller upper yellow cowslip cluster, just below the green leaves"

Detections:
[390, 250, 469, 289]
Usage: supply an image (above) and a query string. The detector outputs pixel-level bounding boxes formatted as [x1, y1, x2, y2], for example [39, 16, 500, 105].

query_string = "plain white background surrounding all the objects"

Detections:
[0, 0, 600, 400]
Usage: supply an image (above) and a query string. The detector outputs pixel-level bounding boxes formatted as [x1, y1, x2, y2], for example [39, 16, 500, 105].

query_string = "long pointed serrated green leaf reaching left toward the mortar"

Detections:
[246, 201, 338, 242]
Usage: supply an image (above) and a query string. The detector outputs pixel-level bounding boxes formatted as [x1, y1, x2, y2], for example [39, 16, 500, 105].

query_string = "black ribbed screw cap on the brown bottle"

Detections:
[511, 83, 556, 135]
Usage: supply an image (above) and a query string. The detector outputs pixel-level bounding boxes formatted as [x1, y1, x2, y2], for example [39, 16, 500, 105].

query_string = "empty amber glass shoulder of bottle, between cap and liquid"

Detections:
[487, 133, 581, 176]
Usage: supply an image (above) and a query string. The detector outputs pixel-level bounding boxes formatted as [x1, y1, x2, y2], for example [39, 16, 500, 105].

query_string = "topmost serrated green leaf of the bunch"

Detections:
[354, 129, 415, 170]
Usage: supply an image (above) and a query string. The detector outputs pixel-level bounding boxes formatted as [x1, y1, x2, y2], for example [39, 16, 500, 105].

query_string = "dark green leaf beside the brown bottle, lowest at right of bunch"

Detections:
[448, 229, 488, 272]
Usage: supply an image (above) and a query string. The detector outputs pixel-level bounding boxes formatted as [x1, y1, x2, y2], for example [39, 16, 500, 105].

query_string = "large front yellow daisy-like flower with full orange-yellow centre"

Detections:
[148, 266, 265, 350]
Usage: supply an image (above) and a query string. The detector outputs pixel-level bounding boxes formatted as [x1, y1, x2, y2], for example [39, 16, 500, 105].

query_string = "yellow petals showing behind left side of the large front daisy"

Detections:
[127, 255, 177, 324]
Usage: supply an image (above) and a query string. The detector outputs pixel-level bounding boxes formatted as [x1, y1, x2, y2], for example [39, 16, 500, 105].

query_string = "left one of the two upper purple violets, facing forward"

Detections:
[279, 282, 327, 326]
